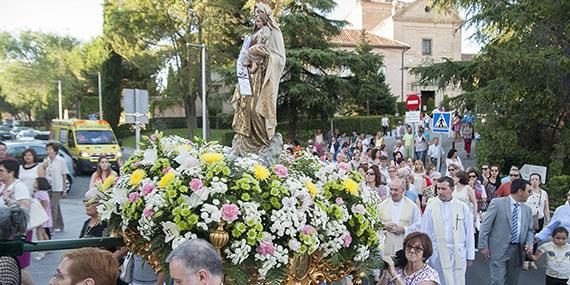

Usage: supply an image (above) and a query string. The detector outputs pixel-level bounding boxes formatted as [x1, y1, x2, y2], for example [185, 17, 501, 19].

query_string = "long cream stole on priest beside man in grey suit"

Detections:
[432, 199, 465, 285]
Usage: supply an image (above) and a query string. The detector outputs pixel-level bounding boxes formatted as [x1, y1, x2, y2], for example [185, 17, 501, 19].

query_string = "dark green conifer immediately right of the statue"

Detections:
[278, 0, 351, 140]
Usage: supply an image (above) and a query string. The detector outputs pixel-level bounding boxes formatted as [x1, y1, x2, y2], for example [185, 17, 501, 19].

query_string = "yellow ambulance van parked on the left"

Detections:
[50, 119, 123, 173]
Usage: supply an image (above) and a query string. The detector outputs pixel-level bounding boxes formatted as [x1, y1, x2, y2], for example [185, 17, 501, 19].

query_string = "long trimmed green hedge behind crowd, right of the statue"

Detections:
[277, 115, 404, 142]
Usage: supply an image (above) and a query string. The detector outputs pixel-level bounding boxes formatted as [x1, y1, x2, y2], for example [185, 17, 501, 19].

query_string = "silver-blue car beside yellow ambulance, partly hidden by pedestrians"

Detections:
[4, 140, 75, 192]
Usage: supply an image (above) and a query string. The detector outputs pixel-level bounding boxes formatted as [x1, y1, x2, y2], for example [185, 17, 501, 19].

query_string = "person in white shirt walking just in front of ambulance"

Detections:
[40, 143, 67, 232]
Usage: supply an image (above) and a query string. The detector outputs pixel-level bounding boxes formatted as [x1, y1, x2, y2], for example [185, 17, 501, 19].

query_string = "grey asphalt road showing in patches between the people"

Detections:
[28, 137, 545, 285]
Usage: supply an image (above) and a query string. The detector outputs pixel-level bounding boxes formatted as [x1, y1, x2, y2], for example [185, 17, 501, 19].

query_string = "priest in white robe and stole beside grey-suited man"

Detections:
[421, 176, 475, 285]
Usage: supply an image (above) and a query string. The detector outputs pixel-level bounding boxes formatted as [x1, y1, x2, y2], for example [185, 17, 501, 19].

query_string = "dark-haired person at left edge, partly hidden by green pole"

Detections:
[0, 201, 28, 284]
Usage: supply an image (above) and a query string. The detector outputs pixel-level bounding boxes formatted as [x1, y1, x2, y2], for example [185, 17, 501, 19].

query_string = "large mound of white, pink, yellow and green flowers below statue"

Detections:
[98, 133, 383, 284]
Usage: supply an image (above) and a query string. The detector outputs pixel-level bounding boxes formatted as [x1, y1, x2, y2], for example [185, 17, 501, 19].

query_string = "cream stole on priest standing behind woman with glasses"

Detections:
[380, 197, 414, 255]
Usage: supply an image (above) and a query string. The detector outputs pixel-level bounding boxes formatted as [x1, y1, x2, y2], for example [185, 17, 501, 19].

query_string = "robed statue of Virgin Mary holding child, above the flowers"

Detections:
[231, 3, 285, 162]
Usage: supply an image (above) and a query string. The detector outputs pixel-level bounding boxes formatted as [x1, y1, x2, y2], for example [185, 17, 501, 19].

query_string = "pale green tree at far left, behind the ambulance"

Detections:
[0, 31, 89, 122]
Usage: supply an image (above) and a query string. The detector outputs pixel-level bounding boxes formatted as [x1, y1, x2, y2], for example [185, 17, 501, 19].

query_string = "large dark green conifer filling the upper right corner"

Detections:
[412, 0, 570, 175]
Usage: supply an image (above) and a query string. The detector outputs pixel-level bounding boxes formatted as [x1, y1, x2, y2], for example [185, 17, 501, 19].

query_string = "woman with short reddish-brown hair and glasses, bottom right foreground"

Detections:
[380, 232, 440, 285]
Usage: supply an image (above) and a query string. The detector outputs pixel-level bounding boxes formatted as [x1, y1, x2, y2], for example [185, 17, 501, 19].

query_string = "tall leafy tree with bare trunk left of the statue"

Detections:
[104, 0, 244, 136]
